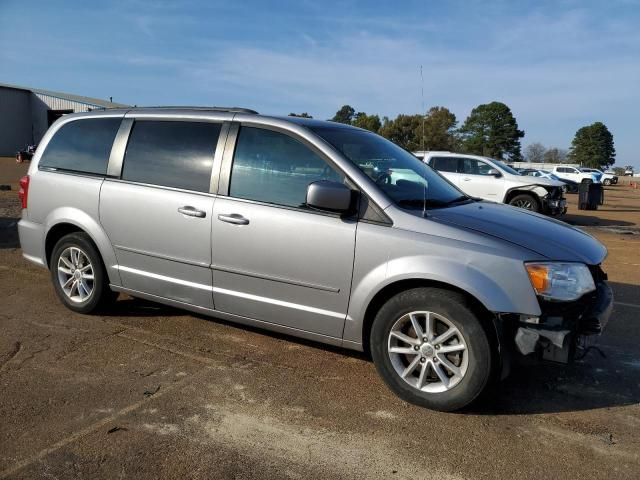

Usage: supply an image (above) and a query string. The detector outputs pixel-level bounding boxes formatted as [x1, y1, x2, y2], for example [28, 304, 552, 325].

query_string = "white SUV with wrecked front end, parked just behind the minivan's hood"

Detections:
[414, 152, 567, 215]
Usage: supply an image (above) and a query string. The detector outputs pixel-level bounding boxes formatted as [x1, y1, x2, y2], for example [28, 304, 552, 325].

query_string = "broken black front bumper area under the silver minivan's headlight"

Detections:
[502, 274, 613, 363]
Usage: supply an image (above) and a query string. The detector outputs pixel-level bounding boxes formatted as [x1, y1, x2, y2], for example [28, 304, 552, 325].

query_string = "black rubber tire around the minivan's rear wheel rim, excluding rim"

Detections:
[49, 232, 117, 314]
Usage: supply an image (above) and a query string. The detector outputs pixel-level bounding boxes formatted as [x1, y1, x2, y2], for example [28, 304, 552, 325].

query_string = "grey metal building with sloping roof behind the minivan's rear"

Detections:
[0, 83, 128, 156]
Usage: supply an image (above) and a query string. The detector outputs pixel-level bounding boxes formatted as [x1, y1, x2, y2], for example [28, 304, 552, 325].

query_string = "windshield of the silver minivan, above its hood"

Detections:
[311, 127, 470, 210]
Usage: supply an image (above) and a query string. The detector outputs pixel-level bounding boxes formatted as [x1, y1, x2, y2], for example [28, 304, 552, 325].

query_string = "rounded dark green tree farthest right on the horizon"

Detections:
[569, 122, 616, 168]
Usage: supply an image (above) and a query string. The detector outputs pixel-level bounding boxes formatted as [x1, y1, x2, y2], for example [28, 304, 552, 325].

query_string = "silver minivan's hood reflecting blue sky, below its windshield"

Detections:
[429, 202, 607, 265]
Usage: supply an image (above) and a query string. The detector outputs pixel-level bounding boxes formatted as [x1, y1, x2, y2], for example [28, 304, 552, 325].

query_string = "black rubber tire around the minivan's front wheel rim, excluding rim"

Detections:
[370, 288, 498, 412]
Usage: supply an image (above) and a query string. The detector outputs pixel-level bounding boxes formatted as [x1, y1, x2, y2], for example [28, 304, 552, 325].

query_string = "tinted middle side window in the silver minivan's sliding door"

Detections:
[122, 120, 221, 192]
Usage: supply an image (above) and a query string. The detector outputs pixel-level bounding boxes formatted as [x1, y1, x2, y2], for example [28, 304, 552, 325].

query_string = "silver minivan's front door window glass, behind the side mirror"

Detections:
[229, 127, 344, 207]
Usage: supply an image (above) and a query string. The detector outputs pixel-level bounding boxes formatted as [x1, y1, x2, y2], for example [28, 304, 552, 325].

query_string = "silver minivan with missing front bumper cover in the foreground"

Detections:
[19, 107, 613, 410]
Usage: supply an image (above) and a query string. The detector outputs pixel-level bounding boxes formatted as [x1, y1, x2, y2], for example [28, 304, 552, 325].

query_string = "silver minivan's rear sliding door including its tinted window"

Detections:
[100, 119, 224, 308]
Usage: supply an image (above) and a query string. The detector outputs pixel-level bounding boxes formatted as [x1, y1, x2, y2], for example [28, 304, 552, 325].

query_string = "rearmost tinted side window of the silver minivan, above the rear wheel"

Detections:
[39, 118, 121, 175]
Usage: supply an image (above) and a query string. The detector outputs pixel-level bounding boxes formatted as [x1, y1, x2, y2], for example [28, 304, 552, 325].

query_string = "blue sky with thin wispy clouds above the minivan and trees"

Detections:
[0, 0, 640, 168]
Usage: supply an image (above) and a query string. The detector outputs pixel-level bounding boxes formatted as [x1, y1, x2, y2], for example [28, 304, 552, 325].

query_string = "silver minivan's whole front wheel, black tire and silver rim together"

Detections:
[370, 288, 492, 411]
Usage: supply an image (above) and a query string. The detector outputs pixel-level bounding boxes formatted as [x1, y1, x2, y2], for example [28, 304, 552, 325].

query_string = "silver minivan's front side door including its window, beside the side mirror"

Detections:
[212, 127, 357, 337]
